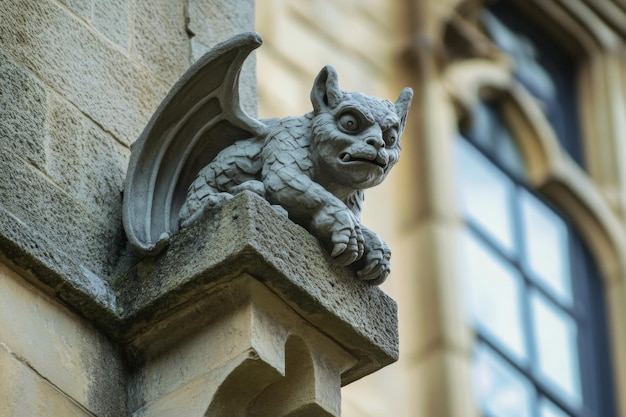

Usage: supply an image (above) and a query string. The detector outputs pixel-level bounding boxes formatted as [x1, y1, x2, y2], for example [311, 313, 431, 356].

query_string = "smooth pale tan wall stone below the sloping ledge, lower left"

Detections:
[0, 266, 126, 417]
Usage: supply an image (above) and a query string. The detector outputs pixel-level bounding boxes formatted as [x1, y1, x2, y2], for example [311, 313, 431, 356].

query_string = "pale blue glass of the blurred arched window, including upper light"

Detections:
[456, 4, 615, 417]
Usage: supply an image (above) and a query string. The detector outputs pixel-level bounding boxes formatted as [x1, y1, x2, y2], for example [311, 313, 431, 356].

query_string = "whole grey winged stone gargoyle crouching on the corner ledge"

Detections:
[123, 33, 413, 285]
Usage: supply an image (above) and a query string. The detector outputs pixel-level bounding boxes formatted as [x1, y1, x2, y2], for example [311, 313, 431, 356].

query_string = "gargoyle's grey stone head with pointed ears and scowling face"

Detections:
[311, 66, 413, 190]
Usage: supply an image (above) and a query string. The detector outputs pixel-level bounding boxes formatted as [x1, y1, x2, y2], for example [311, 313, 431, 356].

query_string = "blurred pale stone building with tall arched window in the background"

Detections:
[256, 0, 626, 417]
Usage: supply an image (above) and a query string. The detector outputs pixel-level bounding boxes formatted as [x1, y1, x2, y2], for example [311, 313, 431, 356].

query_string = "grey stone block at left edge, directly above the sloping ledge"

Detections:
[0, 149, 123, 281]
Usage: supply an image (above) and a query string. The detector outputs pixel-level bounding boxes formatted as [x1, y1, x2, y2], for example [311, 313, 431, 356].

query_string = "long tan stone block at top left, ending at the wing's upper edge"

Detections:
[0, 0, 167, 145]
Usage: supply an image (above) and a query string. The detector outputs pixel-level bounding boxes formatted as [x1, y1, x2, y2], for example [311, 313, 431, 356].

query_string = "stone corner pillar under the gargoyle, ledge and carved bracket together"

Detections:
[118, 192, 398, 417]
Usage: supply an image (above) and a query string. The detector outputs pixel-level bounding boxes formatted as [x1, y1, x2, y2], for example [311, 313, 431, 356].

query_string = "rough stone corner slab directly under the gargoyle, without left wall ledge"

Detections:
[118, 193, 398, 384]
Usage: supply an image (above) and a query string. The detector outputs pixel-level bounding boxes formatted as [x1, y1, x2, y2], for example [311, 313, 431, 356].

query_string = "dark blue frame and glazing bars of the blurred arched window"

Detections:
[456, 103, 616, 417]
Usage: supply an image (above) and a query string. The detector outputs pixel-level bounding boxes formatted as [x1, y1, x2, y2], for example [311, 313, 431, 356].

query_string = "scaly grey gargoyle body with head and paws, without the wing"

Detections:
[180, 66, 413, 285]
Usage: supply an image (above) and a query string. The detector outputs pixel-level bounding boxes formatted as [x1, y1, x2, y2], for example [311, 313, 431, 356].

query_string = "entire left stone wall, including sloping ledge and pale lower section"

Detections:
[0, 0, 250, 417]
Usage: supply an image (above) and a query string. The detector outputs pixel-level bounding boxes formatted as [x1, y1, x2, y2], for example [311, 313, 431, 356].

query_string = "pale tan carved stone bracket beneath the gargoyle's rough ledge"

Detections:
[129, 274, 355, 417]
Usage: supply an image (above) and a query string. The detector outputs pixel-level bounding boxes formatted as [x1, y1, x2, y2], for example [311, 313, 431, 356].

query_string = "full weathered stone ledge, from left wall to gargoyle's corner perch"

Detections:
[0, 188, 398, 385]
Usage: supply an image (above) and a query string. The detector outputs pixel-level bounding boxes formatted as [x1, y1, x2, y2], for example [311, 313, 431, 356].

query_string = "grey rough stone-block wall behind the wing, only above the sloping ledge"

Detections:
[0, 0, 256, 292]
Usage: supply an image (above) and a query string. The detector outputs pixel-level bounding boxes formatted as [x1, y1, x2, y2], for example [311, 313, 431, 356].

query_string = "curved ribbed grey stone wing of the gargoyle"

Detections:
[123, 32, 266, 255]
